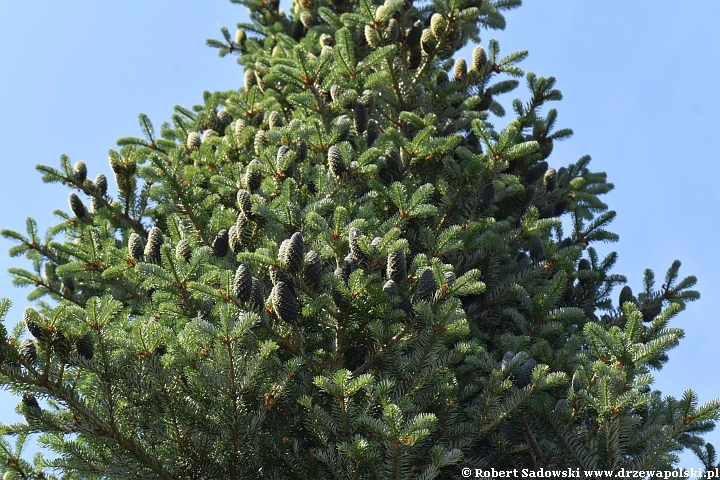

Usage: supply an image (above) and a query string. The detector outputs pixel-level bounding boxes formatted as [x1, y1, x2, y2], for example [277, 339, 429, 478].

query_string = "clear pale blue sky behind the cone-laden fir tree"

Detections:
[0, 0, 720, 468]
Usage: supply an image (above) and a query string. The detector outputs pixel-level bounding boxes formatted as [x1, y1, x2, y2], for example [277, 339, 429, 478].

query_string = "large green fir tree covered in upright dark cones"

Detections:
[0, 0, 720, 479]
